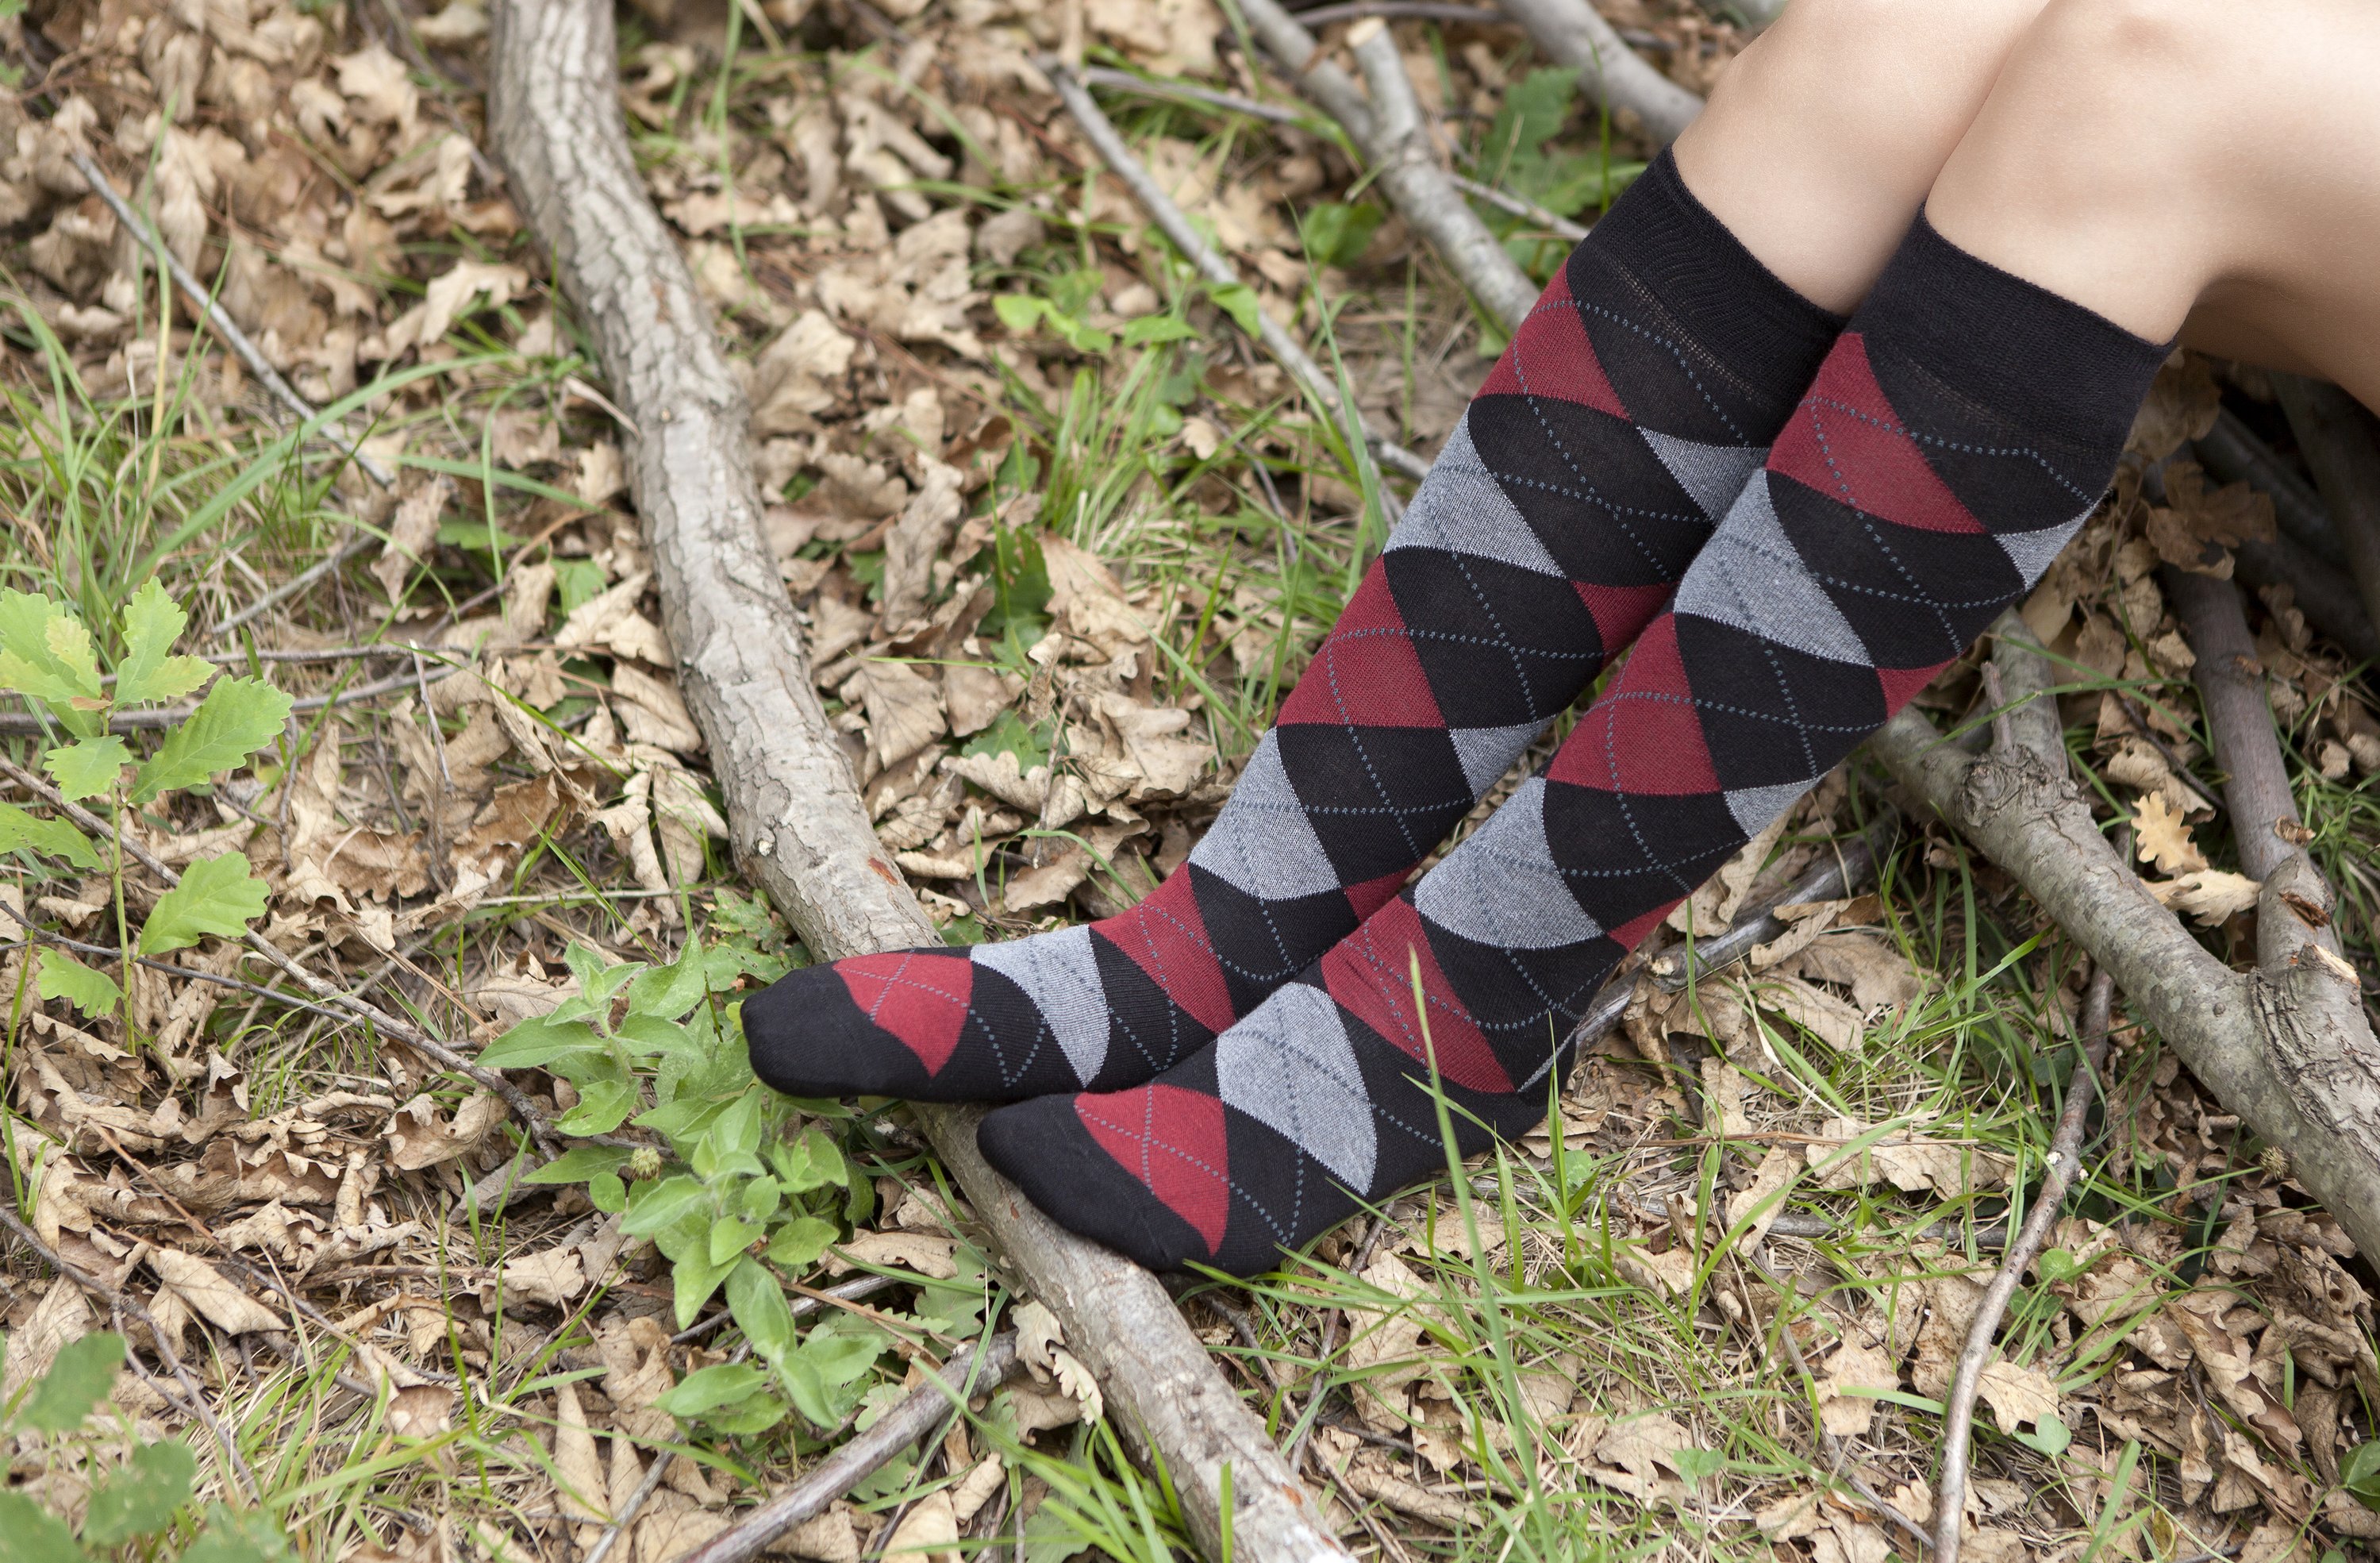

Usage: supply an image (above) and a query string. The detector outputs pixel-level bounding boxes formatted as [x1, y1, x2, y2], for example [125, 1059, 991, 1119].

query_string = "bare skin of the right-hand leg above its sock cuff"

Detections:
[1928, 0, 2380, 404]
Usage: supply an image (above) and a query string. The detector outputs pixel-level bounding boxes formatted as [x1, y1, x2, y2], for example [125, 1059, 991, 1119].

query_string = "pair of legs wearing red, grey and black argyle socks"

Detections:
[745, 0, 2380, 1270]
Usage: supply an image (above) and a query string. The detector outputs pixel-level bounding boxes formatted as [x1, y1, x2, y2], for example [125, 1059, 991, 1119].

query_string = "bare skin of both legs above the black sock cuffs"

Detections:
[1678, 0, 2380, 406]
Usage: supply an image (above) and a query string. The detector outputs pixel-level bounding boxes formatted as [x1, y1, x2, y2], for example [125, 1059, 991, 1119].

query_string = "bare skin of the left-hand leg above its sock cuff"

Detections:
[1678, 0, 2044, 314]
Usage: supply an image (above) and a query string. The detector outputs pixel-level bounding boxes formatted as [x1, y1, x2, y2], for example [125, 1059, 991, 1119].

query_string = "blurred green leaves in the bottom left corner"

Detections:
[0, 1332, 293, 1563]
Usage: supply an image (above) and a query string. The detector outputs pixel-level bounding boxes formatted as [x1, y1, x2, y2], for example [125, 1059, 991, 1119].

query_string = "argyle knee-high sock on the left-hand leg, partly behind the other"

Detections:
[745, 155, 1842, 1102]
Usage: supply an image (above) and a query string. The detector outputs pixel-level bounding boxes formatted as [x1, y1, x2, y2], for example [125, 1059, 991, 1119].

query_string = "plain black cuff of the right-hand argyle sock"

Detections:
[1851, 212, 2173, 449]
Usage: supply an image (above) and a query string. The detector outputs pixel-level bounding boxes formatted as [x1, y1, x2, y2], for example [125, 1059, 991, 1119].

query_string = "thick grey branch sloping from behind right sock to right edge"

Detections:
[1868, 656, 2380, 1251]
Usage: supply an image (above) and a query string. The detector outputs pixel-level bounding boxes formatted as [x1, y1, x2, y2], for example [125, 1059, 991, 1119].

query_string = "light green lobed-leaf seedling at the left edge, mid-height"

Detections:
[0, 578, 290, 1016]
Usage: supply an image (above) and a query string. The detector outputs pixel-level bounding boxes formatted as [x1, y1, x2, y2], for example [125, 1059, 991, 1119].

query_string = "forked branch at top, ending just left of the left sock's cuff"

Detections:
[1237, 0, 1537, 331]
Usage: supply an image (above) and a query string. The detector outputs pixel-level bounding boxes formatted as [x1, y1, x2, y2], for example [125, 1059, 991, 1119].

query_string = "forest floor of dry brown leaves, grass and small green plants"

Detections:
[0, 0, 2380, 1563]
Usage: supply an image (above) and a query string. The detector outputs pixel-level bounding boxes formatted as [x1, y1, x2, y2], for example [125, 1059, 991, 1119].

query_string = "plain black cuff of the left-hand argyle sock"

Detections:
[1585, 148, 1844, 378]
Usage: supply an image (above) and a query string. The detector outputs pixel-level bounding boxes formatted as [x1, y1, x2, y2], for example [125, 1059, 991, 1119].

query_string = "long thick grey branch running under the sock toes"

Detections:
[490, 0, 1347, 1563]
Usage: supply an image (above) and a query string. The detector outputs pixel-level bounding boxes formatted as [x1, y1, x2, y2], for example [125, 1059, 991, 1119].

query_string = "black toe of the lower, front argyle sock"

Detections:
[976, 1097, 1213, 1270]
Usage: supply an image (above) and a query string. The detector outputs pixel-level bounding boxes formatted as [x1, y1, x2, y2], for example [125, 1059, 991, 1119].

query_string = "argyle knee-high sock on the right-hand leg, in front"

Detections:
[981, 219, 2166, 1272]
